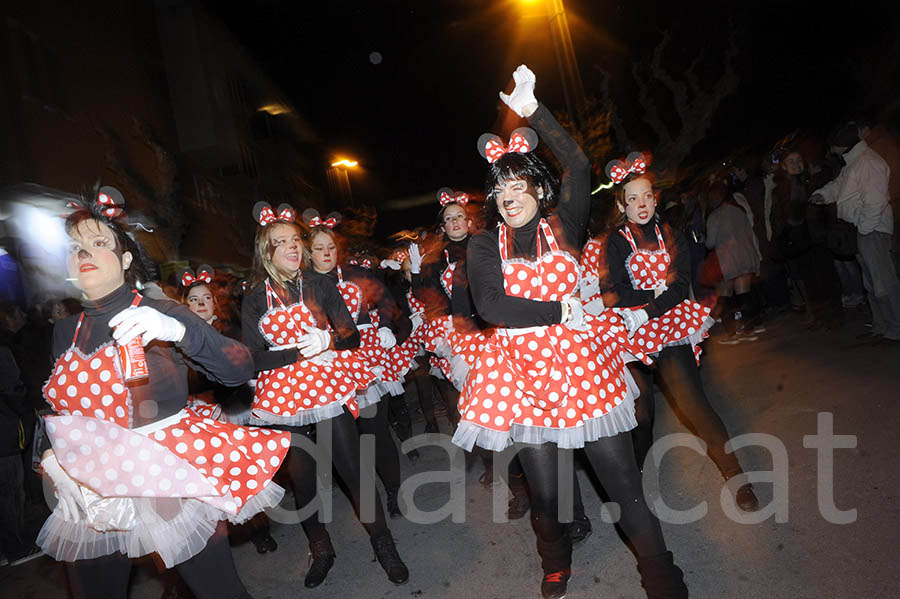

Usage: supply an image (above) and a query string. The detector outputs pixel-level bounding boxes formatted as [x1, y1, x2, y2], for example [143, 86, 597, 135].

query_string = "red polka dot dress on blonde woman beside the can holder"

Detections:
[251, 280, 366, 426]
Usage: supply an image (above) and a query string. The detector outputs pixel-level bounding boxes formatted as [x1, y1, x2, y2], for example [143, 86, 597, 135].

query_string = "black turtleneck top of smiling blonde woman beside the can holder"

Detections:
[241, 277, 359, 372]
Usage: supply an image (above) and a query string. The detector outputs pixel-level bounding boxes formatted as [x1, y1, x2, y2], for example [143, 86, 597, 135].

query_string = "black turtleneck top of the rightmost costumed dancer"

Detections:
[600, 215, 691, 318]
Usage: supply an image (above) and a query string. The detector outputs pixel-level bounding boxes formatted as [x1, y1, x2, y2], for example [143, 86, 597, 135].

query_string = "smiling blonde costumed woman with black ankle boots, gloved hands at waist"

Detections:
[241, 202, 409, 587]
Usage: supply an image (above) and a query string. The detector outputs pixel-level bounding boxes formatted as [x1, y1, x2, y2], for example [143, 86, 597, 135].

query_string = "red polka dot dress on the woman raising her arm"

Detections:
[453, 219, 637, 451]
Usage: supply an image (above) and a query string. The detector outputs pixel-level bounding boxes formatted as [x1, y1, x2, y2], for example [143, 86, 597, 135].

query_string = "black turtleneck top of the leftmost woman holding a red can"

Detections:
[52, 285, 253, 436]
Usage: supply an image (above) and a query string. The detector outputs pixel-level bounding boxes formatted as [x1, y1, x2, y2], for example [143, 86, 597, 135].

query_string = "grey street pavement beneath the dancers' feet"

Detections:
[0, 313, 900, 599]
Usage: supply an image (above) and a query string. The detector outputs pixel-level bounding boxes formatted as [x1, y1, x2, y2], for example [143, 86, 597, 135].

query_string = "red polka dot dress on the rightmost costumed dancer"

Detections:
[596, 225, 714, 363]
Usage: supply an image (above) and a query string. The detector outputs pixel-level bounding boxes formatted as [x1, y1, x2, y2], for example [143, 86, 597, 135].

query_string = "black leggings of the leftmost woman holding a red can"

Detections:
[66, 522, 250, 599]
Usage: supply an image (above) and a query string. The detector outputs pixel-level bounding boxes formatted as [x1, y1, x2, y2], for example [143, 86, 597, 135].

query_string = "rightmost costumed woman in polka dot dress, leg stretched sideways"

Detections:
[582, 159, 759, 511]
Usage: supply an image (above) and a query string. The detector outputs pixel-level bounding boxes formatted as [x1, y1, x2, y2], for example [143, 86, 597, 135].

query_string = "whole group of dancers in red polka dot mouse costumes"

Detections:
[38, 65, 758, 599]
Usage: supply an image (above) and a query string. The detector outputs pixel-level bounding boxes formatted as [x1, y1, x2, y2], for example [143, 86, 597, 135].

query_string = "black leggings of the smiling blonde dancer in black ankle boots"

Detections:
[272, 407, 387, 542]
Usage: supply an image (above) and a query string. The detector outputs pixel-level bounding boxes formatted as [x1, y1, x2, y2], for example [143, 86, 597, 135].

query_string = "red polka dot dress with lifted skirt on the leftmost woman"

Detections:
[37, 296, 290, 567]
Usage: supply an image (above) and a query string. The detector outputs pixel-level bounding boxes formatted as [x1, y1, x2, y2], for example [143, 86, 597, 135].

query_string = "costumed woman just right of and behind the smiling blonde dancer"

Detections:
[303, 208, 411, 518]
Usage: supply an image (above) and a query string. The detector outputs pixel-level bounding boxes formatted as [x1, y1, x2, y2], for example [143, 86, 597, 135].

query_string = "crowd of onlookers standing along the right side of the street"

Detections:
[659, 119, 900, 345]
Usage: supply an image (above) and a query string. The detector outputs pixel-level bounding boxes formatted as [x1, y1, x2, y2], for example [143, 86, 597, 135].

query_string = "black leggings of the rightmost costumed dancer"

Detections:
[628, 345, 741, 478]
